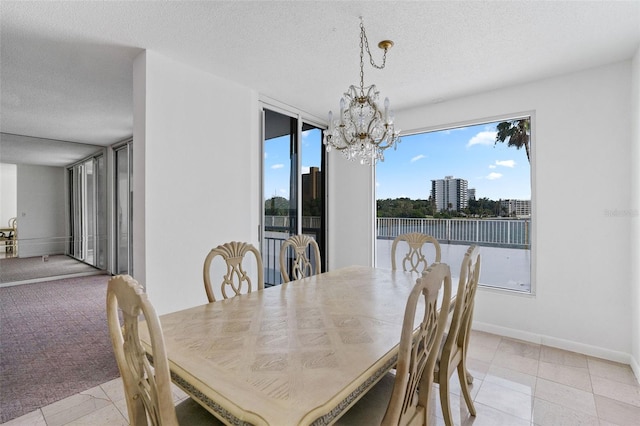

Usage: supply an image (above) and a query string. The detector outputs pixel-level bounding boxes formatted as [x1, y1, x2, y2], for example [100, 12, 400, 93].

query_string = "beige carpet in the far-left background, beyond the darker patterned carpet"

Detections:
[0, 255, 105, 284]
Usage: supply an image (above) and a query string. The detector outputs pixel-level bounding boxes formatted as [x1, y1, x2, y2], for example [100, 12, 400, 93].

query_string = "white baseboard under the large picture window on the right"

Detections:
[473, 321, 640, 382]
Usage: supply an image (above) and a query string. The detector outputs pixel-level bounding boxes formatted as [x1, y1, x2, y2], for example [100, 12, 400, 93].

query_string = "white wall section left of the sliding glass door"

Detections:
[133, 51, 260, 313]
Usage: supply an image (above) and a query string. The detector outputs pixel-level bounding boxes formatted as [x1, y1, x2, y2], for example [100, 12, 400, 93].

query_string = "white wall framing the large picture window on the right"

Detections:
[396, 62, 637, 362]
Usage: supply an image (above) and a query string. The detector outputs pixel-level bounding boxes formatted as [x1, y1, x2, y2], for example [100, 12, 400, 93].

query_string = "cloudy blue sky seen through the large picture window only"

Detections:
[376, 123, 531, 200]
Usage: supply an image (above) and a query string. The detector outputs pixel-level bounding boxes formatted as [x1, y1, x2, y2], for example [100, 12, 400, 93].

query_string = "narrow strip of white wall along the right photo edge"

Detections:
[630, 48, 640, 379]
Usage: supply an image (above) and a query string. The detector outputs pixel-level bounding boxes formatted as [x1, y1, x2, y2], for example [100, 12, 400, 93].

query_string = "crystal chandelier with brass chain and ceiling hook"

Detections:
[323, 17, 400, 165]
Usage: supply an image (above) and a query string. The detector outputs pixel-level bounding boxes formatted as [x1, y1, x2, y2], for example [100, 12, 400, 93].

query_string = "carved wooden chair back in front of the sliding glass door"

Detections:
[280, 235, 321, 283]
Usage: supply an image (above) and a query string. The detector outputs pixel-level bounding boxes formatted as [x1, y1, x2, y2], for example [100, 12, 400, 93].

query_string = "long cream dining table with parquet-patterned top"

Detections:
[141, 266, 448, 426]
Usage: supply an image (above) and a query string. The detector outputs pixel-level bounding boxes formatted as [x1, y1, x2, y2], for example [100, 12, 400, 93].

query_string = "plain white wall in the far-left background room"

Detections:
[17, 165, 69, 257]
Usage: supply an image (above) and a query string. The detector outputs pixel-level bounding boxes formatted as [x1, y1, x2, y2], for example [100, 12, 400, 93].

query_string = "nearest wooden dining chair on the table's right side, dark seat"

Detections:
[335, 263, 451, 426]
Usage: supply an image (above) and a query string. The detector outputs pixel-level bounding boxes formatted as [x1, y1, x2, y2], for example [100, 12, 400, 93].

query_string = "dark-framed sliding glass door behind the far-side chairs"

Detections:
[261, 108, 326, 285]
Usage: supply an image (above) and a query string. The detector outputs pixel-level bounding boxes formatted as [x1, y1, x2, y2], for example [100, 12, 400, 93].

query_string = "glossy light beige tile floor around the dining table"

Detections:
[5, 331, 640, 426]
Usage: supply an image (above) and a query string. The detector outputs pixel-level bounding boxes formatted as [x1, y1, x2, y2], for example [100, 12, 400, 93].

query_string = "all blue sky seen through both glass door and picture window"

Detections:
[264, 119, 531, 200]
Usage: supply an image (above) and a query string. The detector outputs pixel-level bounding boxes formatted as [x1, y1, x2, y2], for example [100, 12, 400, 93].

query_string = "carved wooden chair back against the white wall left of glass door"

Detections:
[202, 241, 264, 302]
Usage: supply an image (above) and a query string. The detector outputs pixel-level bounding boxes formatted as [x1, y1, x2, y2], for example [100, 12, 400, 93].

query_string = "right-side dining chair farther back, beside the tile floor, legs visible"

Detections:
[434, 245, 480, 426]
